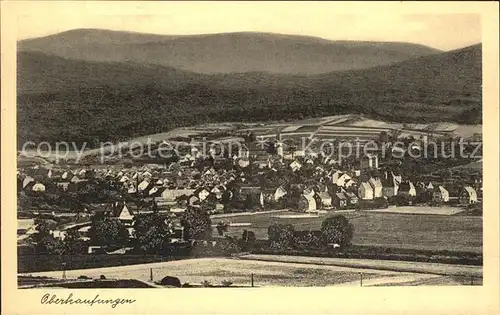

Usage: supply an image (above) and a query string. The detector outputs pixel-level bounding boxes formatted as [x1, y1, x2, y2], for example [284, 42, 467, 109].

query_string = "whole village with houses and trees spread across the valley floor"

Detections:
[17, 119, 482, 260]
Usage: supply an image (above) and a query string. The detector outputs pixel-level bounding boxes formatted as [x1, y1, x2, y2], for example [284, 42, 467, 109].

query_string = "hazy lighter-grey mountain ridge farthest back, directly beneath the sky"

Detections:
[18, 29, 441, 75]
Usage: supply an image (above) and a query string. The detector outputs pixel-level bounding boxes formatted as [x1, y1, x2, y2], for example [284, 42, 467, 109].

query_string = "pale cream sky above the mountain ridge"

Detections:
[11, 1, 481, 50]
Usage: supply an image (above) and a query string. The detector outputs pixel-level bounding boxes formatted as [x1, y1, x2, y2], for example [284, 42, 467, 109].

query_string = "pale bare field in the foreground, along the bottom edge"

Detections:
[16, 258, 446, 286]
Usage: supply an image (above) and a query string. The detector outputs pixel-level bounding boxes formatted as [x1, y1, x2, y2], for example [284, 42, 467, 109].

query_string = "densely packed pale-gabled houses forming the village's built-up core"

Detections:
[18, 146, 478, 217]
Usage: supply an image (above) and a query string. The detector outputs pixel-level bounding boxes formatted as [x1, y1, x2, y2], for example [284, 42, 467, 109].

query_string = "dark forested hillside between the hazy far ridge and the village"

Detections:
[17, 45, 482, 147]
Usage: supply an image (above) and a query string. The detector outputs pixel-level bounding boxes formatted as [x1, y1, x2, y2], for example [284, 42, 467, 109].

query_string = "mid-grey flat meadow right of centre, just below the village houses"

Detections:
[212, 211, 483, 253]
